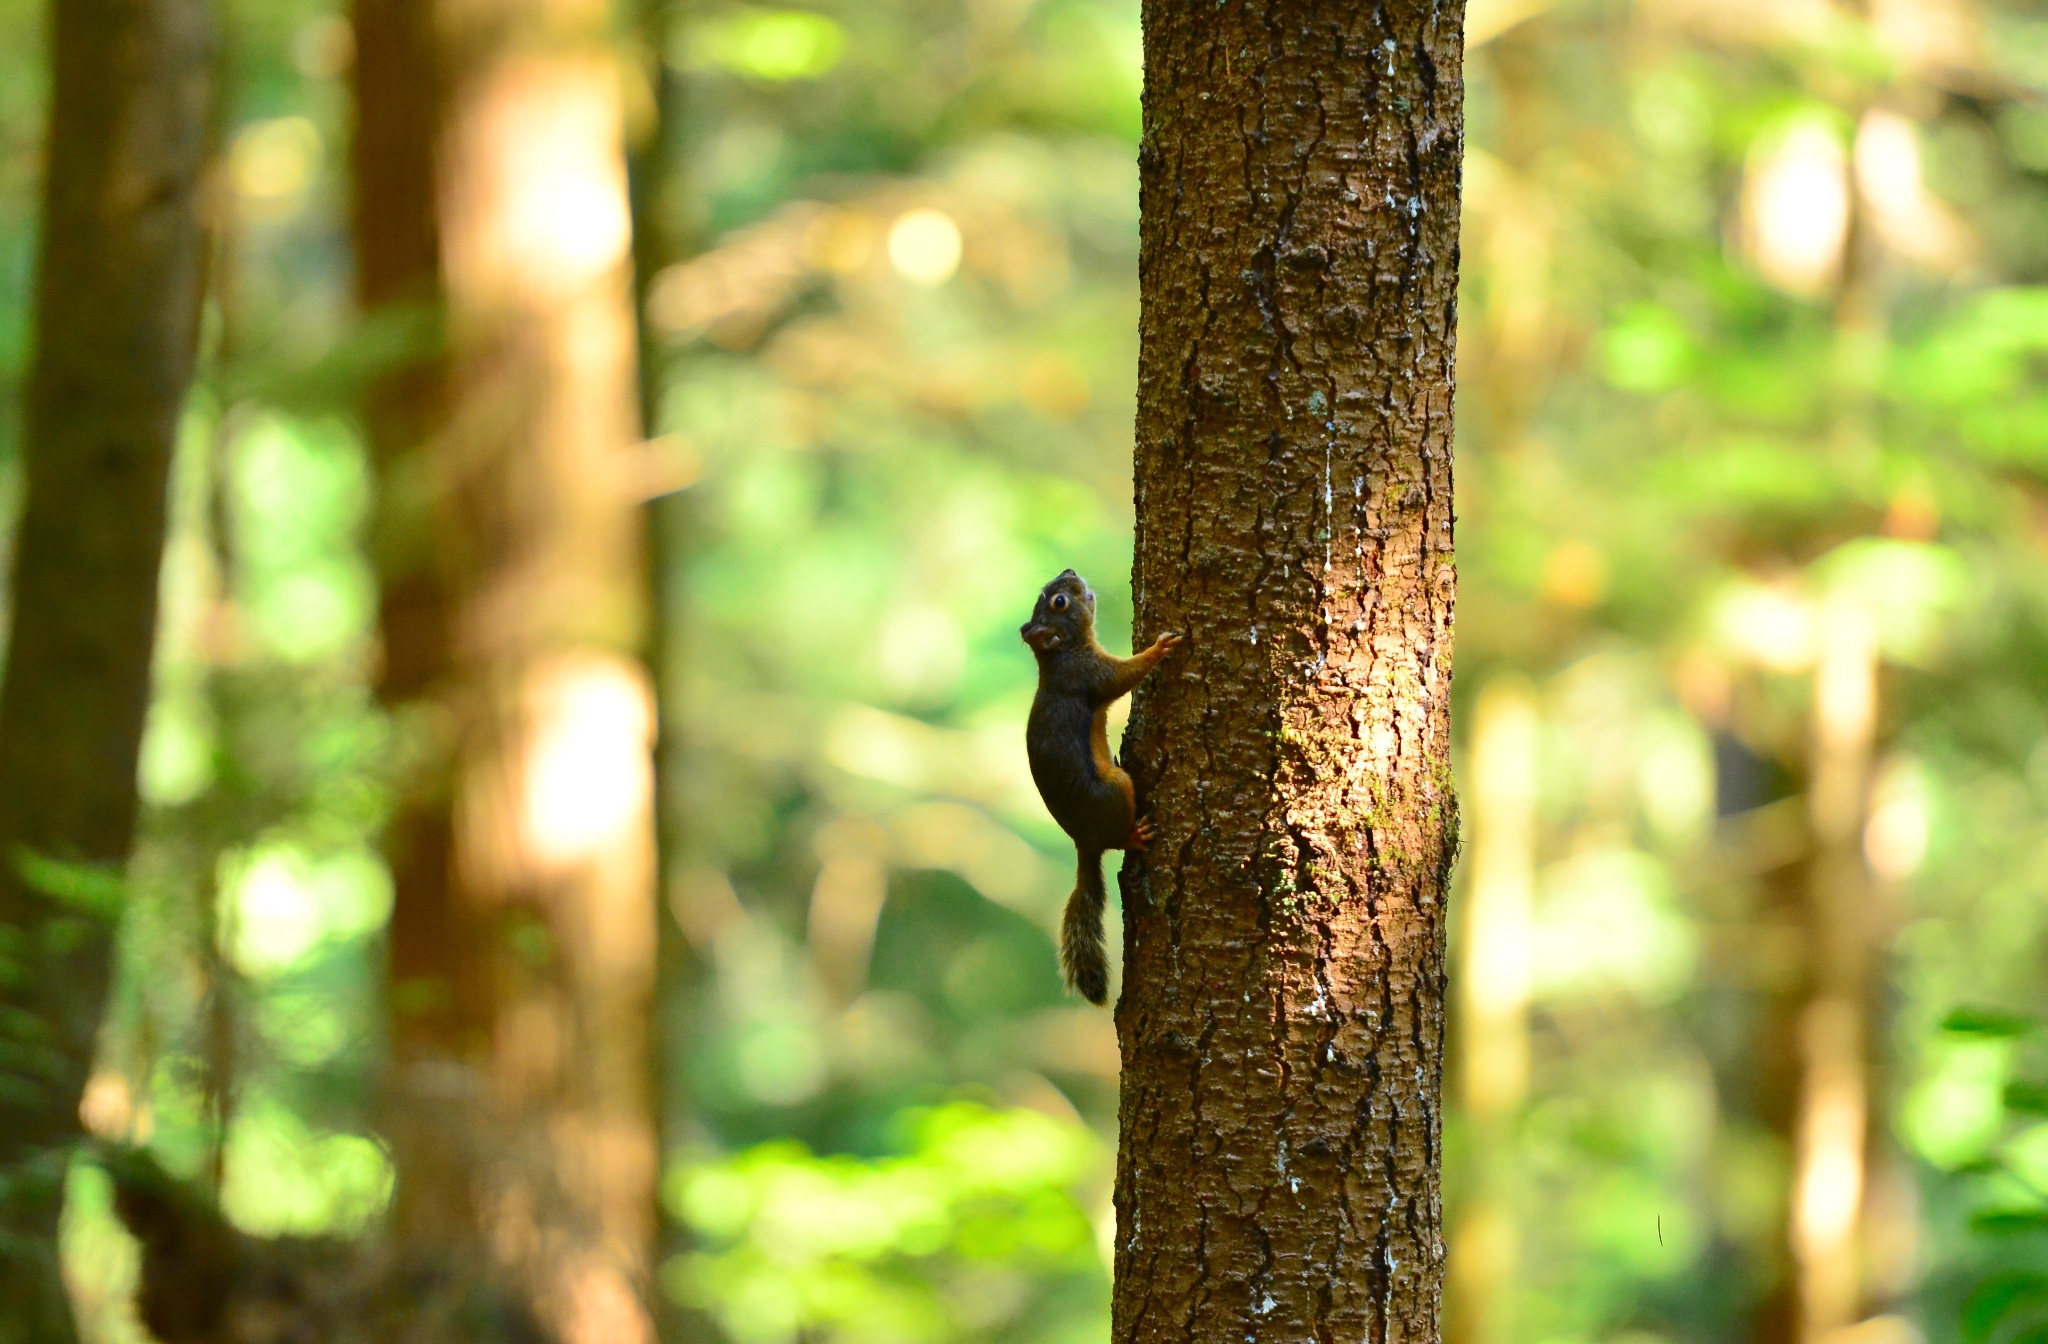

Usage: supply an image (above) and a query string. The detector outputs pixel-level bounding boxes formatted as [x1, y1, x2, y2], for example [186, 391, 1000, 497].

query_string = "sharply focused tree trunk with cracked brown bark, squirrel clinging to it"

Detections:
[1114, 0, 1464, 1344]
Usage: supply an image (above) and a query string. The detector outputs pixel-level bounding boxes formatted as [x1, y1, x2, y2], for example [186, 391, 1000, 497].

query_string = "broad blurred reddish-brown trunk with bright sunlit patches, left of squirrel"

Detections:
[354, 0, 655, 1344]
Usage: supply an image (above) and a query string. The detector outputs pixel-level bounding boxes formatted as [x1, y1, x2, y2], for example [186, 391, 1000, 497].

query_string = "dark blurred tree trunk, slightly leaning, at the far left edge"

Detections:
[0, 0, 211, 1340]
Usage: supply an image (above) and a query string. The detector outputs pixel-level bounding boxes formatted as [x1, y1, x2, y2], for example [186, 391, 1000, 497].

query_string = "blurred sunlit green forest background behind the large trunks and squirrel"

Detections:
[0, 0, 2048, 1344]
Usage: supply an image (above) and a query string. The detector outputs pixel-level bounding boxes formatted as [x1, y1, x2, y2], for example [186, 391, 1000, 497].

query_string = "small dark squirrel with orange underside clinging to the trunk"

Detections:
[1018, 570, 1182, 1004]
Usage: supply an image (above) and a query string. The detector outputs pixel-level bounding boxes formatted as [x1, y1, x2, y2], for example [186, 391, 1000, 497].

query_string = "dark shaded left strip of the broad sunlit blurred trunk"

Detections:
[350, 0, 468, 1248]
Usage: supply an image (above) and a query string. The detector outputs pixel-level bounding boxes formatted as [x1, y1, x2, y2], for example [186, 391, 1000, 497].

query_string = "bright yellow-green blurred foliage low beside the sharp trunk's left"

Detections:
[664, 1102, 1102, 1344]
